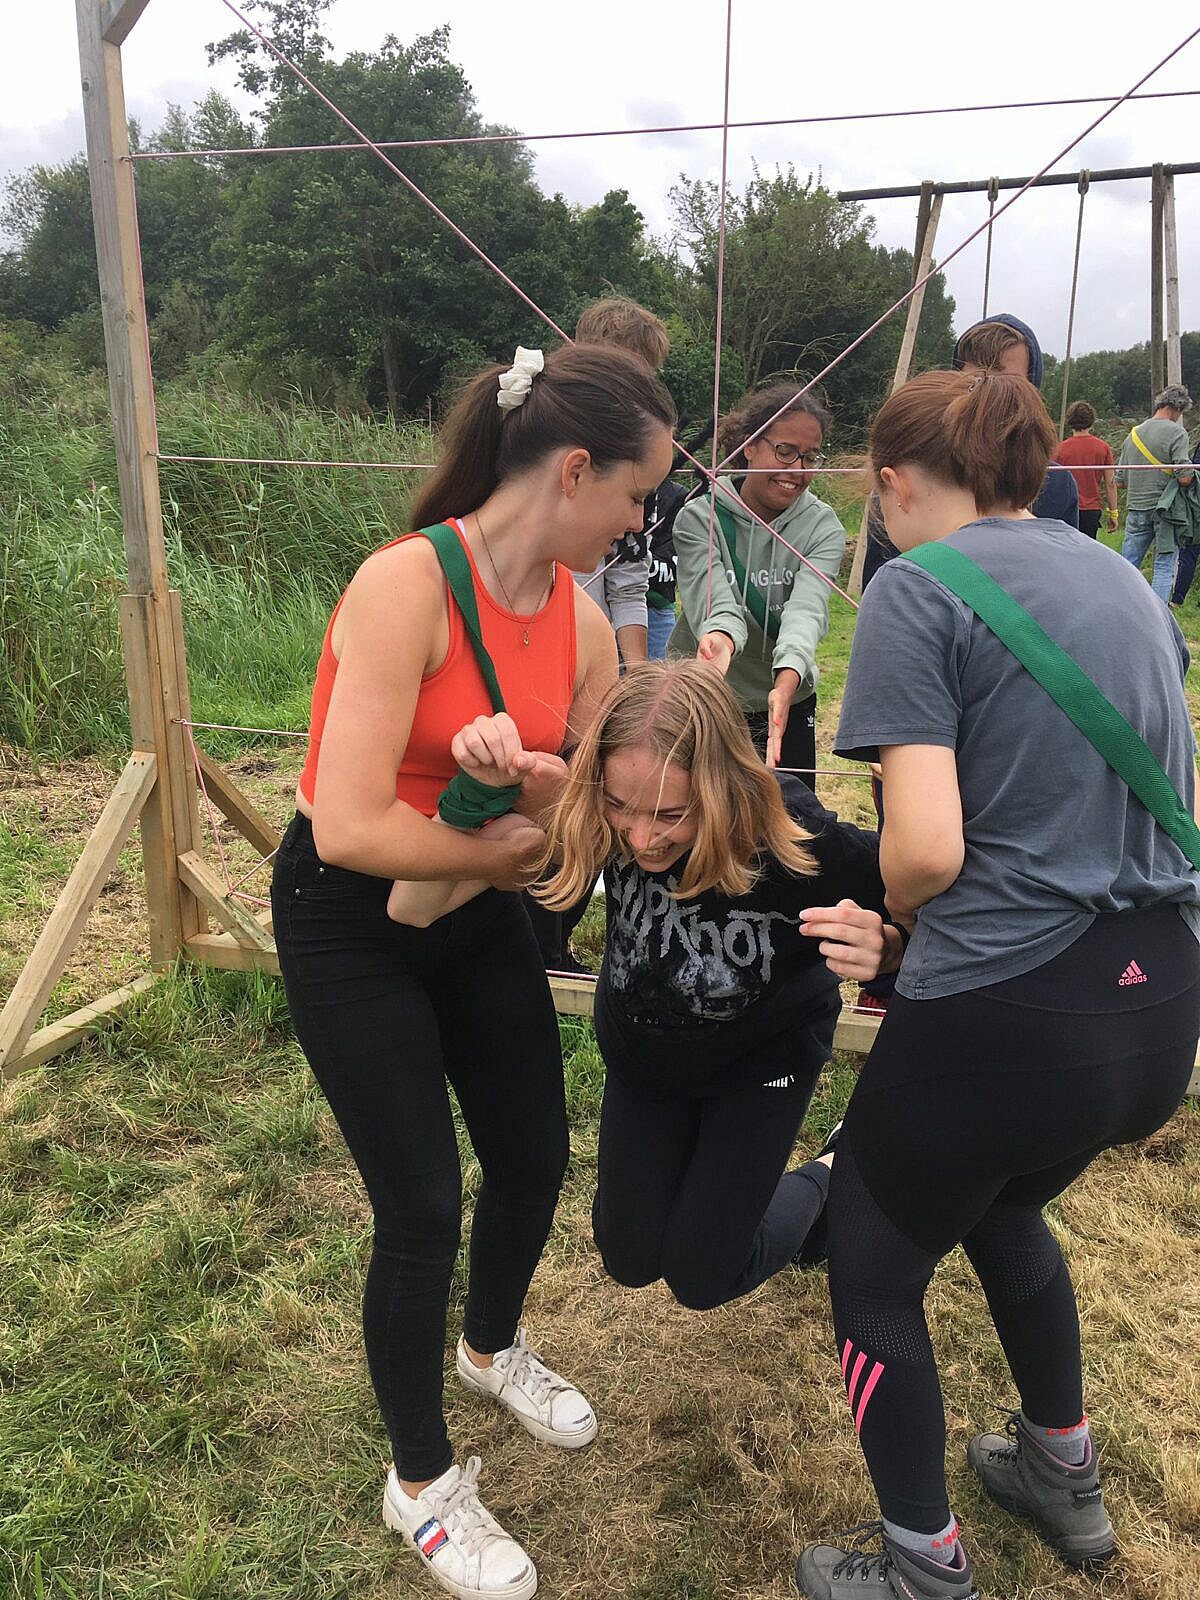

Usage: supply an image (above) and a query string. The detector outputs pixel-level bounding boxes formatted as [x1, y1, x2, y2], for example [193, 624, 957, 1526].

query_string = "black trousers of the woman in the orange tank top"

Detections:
[270, 816, 568, 1482]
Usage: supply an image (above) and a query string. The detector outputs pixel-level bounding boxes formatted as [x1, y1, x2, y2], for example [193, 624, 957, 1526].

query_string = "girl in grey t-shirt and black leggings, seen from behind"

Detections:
[797, 373, 1200, 1600]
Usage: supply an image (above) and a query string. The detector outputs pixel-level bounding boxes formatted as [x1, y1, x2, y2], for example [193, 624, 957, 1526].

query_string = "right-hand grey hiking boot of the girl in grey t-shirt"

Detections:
[966, 1411, 1117, 1566]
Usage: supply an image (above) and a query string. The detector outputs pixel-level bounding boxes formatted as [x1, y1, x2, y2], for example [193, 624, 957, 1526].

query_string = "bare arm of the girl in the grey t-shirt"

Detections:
[880, 744, 966, 918]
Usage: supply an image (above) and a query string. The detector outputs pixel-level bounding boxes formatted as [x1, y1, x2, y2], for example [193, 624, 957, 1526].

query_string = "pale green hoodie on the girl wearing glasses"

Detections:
[670, 478, 846, 710]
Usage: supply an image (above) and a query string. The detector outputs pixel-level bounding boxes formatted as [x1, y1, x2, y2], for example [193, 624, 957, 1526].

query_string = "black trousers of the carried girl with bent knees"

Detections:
[592, 1032, 829, 1310]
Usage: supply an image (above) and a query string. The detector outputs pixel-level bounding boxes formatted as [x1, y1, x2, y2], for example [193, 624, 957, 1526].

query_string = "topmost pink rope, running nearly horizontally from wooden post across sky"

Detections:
[128, 90, 1200, 162]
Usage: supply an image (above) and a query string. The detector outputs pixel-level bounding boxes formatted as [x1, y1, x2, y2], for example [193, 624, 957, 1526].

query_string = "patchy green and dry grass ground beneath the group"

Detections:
[0, 428, 1200, 1600]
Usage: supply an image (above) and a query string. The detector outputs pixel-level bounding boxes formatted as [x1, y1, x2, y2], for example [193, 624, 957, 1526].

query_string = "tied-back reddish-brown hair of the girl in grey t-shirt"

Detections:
[869, 373, 1058, 512]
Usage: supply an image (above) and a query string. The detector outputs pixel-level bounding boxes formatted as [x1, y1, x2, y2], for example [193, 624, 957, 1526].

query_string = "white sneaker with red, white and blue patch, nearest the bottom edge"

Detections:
[384, 1456, 538, 1600]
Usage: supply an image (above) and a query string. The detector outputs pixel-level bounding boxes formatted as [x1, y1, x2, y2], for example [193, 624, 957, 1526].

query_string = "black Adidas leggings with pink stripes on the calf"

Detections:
[829, 907, 1200, 1533]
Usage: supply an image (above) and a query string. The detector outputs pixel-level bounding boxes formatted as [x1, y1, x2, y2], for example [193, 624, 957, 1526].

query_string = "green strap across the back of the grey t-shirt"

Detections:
[904, 541, 1200, 869]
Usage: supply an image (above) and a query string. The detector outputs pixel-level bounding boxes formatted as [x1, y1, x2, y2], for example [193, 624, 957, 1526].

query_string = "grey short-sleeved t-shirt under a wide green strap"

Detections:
[835, 517, 1200, 1000]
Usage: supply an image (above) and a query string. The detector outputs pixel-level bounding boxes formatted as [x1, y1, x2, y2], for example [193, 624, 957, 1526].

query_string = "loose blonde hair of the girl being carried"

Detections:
[534, 661, 818, 910]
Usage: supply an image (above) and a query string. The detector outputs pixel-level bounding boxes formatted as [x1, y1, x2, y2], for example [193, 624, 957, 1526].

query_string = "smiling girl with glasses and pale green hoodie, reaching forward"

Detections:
[670, 382, 846, 789]
